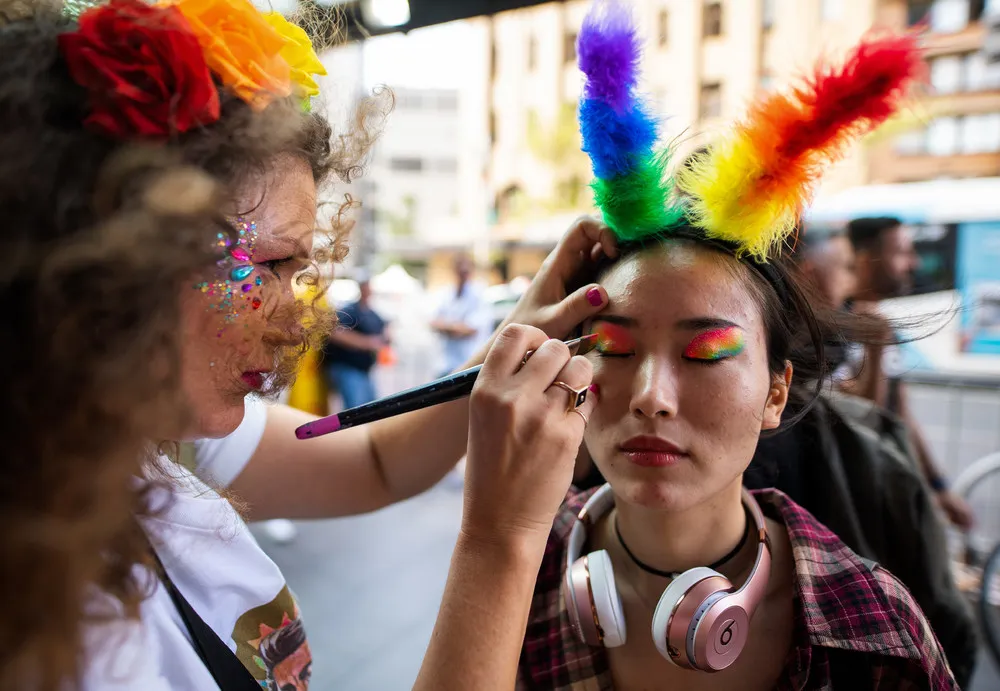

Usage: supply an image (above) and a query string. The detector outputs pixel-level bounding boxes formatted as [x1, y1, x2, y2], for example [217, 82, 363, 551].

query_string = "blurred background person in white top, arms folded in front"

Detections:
[431, 254, 493, 376]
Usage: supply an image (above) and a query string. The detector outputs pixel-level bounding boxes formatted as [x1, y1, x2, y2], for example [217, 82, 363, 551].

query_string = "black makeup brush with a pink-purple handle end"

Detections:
[295, 334, 598, 439]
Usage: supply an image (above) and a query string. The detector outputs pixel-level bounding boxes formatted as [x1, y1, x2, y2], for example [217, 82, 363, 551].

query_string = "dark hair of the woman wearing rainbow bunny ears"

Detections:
[599, 225, 884, 429]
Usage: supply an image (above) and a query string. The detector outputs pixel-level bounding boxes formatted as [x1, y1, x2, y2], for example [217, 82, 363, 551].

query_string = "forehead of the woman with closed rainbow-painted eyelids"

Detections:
[601, 243, 762, 328]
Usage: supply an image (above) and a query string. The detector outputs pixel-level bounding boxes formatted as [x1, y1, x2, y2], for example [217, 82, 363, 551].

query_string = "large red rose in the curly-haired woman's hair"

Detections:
[59, 0, 219, 139]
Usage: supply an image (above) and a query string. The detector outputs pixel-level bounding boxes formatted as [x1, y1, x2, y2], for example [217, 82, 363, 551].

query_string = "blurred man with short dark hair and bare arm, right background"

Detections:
[836, 217, 973, 530]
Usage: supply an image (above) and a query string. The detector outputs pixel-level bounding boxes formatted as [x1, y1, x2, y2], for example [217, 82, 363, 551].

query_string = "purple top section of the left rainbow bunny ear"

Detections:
[577, 0, 642, 111]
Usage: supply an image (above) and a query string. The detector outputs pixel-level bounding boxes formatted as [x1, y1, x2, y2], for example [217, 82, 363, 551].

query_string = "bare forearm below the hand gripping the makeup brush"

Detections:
[413, 534, 545, 691]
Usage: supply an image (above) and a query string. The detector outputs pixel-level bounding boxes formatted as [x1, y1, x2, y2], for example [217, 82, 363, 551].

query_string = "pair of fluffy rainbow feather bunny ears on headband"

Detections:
[577, 0, 926, 263]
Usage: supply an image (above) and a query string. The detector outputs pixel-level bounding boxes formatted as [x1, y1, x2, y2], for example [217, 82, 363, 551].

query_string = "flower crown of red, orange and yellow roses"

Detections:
[59, 0, 326, 139]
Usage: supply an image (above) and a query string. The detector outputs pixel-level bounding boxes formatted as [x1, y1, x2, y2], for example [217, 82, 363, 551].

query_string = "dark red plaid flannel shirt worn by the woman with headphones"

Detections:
[517, 490, 958, 691]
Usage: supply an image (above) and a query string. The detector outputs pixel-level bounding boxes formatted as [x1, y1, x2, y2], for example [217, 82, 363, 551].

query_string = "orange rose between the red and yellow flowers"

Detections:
[165, 0, 292, 110]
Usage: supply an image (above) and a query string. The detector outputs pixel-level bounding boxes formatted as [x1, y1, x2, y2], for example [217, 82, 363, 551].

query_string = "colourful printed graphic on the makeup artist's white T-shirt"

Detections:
[233, 586, 312, 691]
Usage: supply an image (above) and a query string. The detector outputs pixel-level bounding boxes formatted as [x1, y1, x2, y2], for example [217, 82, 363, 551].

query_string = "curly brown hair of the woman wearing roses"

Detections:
[0, 0, 386, 691]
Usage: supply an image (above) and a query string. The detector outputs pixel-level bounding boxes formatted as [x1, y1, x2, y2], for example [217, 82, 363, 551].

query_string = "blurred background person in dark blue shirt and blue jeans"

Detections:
[323, 274, 389, 408]
